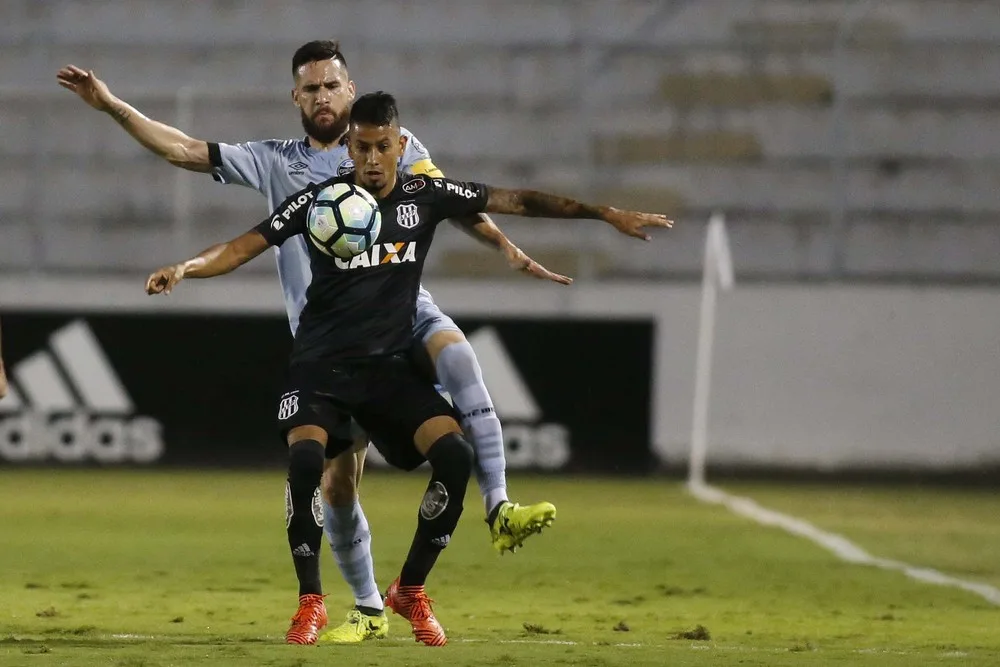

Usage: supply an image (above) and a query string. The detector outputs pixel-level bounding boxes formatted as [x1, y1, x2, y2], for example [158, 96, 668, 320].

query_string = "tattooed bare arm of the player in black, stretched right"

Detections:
[486, 187, 674, 241]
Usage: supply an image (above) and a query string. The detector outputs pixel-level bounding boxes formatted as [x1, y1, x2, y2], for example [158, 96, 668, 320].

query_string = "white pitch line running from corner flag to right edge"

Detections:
[688, 483, 1000, 606]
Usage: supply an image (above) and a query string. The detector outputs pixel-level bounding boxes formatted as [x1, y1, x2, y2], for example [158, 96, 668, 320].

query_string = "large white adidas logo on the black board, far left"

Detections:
[0, 320, 164, 463]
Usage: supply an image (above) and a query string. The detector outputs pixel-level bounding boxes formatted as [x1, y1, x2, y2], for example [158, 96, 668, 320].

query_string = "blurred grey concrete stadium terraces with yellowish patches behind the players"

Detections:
[0, 0, 1000, 281]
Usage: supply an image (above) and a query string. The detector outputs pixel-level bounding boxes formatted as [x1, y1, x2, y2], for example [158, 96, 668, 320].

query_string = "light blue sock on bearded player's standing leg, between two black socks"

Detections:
[323, 499, 382, 609]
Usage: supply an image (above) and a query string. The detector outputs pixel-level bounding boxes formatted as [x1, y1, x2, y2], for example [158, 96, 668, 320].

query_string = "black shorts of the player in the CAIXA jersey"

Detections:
[278, 355, 457, 470]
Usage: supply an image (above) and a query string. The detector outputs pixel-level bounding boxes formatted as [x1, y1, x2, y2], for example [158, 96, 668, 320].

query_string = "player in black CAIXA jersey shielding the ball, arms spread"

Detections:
[146, 92, 672, 646]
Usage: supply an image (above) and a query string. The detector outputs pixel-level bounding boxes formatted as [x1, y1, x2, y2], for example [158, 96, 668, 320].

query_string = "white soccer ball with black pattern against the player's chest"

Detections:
[307, 183, 382, 259]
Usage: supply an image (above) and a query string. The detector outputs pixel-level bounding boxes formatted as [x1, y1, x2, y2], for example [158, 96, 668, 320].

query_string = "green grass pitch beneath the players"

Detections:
[0, 470, 1000, 667]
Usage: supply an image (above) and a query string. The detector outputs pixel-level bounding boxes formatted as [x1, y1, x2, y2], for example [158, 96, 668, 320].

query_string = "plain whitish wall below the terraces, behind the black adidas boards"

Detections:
[0, 276, 1000, 470]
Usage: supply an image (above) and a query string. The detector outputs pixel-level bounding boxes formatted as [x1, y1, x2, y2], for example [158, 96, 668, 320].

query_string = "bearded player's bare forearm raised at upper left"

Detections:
[56, 65, 212, 172]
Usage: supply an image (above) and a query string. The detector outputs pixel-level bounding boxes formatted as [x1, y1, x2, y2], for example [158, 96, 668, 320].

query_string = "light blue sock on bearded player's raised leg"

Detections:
[436, 342, 507, 513]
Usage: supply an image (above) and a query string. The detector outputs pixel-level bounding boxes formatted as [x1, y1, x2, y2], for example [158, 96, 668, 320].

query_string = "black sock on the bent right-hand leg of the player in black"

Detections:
[399, 433, 475, 586]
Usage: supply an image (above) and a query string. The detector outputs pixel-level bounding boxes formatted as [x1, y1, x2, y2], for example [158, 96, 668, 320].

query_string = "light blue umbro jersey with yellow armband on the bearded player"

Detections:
[209, 128, 442, 335]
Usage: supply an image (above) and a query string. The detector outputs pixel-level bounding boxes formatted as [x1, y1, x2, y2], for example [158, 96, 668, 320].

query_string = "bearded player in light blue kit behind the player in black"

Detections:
[57, 41, 569, 643]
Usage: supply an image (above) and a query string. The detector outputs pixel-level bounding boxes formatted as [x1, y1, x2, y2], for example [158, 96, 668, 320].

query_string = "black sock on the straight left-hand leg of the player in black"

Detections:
[285, 440, 324, 596]
